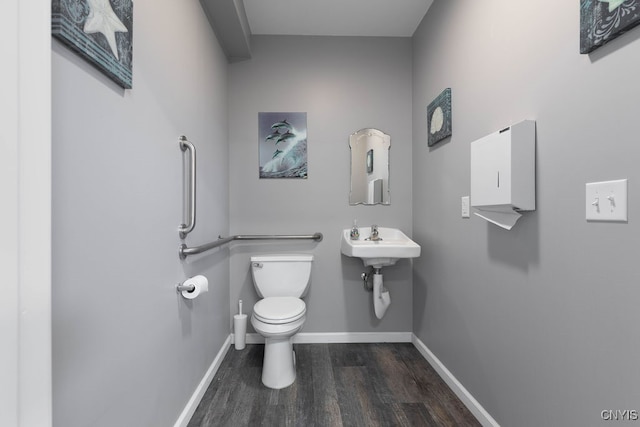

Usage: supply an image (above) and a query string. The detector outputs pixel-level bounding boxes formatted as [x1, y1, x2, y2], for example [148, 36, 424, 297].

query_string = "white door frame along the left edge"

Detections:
[0, 0, 52, 427]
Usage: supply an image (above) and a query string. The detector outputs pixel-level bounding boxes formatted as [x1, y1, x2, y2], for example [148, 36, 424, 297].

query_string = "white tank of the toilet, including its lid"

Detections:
[251, 254, 313, 298]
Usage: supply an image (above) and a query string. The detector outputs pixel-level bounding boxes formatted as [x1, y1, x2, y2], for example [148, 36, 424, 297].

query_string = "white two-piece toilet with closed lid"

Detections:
[251, 254, 313, 389]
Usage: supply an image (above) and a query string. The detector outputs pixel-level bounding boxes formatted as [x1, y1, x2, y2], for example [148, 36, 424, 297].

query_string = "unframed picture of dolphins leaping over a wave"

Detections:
[258, 113, 307, 178]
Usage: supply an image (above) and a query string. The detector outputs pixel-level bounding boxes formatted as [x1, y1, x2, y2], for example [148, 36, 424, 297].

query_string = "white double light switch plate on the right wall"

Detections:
[585, 179, 627, 221]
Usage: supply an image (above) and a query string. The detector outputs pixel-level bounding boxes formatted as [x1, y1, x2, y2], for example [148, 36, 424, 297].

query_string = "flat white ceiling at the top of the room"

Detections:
[244, 0, 433, 37]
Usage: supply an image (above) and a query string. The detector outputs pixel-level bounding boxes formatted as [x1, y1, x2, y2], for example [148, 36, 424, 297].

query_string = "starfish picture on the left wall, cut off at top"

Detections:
[51, 0, 133, 89]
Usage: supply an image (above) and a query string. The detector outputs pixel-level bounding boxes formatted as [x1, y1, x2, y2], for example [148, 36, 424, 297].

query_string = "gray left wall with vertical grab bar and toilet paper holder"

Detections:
[52, 0, 229, 427]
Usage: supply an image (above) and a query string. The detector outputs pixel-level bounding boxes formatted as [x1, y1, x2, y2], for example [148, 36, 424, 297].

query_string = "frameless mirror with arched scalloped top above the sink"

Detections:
[349, 129, 391, 205]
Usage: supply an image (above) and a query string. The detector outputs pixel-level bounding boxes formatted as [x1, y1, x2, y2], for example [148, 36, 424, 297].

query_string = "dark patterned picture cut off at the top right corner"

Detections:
[580, 0, 640, 53]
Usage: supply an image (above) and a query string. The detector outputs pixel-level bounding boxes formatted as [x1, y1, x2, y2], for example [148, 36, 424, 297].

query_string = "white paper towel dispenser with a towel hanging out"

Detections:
[471, 120, 536, 230]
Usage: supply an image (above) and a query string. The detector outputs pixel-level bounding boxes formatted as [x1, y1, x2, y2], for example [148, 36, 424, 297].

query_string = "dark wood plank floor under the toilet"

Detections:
[189, 343, 480, 427]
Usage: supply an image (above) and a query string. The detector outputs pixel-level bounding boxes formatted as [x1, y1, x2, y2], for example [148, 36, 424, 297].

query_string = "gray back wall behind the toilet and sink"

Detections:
[229, 36, 411, 332]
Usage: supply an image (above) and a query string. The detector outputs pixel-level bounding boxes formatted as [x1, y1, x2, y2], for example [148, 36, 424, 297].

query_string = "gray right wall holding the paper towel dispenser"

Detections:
[413, 0, 640, 426]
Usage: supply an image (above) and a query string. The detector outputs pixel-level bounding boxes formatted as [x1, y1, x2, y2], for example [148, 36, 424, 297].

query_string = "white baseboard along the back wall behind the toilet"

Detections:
[231, 332, 413, 344]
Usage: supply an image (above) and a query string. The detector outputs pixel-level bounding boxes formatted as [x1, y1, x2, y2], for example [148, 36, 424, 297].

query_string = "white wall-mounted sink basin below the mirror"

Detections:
[340, 227, 420, 268]
